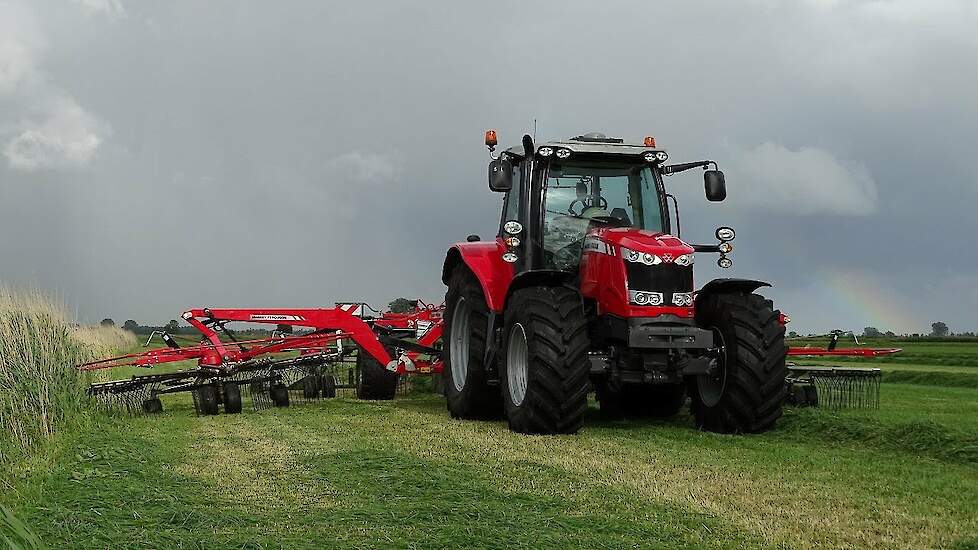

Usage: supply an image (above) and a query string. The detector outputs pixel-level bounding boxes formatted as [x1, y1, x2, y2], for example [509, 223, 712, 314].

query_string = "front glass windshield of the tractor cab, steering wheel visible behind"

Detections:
[543, 163, 663, 270]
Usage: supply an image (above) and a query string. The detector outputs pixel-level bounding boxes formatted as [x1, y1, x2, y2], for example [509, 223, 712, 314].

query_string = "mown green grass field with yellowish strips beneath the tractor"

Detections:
[0, 338, 978, 548]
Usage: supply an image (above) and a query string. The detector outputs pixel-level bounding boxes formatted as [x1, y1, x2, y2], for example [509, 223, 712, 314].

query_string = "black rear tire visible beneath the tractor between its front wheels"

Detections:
[597, 384, 686, 419]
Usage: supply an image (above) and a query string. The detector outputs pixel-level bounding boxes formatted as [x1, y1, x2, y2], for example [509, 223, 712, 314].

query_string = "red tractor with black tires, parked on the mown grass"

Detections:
[442, 130, 788, 434]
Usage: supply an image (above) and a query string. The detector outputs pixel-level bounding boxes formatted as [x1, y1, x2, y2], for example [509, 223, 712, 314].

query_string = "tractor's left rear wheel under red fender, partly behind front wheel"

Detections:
[442, 265, 502, 419]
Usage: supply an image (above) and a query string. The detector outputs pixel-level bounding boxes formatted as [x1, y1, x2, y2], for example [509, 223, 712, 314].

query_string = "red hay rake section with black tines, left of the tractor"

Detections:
[78, 301, 443, 415]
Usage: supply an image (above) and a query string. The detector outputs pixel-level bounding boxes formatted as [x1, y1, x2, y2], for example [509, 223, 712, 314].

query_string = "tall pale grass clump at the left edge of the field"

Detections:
[0, 287, 133, 463]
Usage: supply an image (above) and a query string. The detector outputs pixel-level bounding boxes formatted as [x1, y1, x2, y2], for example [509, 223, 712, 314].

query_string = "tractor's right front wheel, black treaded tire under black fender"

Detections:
[690, 293, 788, 433]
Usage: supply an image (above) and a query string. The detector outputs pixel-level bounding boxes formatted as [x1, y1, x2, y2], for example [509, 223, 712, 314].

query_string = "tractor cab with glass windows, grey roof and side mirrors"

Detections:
[487, 133, 726, 280]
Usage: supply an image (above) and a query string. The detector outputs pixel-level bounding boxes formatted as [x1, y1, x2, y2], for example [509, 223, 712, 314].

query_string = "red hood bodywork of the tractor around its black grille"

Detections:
[581, 227, 694, 318]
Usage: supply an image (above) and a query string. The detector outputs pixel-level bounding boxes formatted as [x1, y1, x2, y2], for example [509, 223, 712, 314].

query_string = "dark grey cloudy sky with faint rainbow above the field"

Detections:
[0, 0, 978, 332]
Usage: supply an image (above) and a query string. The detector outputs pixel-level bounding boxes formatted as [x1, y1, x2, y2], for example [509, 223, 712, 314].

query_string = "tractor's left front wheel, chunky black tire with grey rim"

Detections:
[499, 287, 591, 434]
